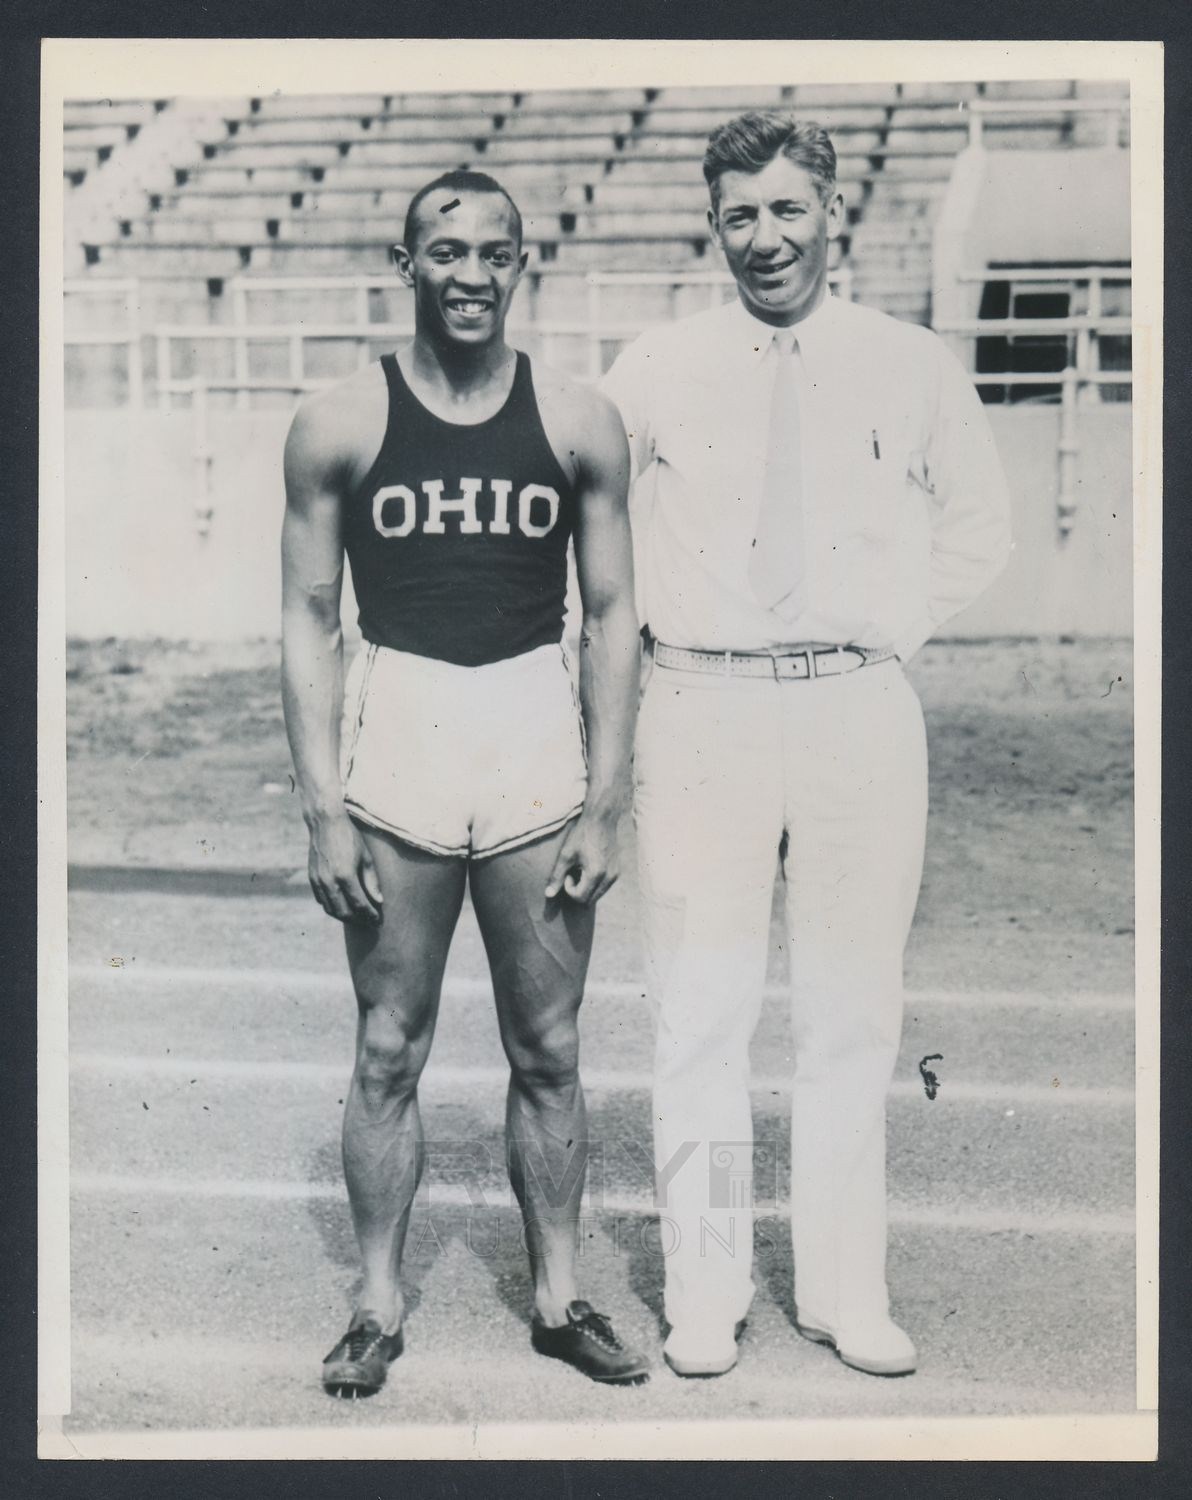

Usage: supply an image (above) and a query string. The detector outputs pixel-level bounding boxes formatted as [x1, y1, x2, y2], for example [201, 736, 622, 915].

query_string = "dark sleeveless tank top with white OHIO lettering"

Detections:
[343, 353, 576, 666]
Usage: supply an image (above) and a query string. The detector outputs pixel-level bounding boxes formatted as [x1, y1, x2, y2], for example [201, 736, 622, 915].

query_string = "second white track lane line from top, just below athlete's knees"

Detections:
[70, 1052, 1134, 1110]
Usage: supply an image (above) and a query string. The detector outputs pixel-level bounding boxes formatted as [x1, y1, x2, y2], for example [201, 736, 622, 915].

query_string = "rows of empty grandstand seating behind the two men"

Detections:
[63, 81, 1126, 402]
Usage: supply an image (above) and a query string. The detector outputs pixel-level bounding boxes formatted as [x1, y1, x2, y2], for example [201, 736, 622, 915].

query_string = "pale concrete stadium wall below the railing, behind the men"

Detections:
[66, 405, 1132, 641]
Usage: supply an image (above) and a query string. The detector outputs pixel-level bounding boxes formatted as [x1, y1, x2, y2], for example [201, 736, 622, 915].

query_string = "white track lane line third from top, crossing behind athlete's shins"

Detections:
[70, 1172, 1135, 1236]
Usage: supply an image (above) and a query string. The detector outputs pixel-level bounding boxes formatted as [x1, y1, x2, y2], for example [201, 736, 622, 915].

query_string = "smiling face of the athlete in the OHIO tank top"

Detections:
[394, 189, 528, 344]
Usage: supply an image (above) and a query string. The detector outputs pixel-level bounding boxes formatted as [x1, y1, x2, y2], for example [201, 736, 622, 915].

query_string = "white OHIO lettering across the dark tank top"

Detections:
[372, 479, 559, 539]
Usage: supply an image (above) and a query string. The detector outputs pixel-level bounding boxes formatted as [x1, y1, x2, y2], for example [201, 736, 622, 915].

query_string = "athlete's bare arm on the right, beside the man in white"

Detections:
[540, 378, 640, 905]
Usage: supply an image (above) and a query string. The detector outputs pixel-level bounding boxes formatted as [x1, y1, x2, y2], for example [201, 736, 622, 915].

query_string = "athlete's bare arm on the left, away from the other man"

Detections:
[282, 371, 385, 921]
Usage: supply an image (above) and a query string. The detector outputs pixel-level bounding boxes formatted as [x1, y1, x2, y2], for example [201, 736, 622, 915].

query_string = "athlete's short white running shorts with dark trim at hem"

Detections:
[340, 642, 588, 860]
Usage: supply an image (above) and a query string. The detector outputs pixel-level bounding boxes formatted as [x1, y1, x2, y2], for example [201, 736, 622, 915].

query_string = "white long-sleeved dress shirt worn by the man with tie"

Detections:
[601, 297, 1011, 662]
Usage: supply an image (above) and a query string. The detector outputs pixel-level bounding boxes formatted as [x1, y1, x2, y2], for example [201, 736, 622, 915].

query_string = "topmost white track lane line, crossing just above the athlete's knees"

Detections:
[70, 963, 1134, 1014]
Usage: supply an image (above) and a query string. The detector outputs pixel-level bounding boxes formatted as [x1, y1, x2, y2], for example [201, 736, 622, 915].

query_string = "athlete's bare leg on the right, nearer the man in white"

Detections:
[471, 833, 595, 1328]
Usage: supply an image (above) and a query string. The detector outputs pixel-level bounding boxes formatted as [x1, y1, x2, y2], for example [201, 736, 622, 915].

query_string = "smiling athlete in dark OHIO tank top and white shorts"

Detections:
[280, 173, 648, 1397]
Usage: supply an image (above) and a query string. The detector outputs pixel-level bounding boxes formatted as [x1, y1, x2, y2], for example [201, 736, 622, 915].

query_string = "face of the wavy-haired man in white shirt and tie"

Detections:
[708, 156, 844, 326]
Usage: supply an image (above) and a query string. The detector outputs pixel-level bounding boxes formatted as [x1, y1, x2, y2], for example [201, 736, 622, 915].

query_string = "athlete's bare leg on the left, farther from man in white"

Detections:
[343, 830, 466, 1332]
